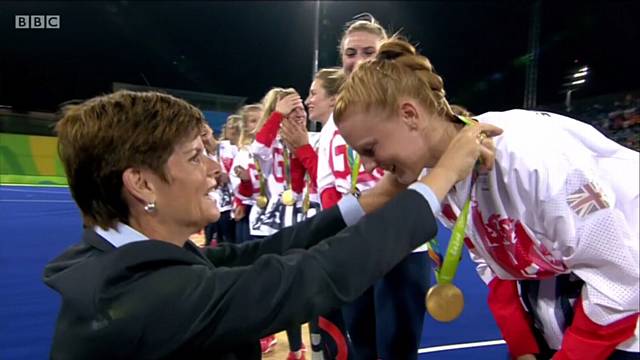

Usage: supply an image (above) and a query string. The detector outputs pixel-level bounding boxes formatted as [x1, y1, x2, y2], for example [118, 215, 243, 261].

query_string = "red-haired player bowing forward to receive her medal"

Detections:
[334, 39, 640, 360]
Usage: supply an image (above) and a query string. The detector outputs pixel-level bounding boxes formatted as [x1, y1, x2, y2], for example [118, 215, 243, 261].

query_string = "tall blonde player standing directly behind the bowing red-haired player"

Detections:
[318, 14, 430, 360]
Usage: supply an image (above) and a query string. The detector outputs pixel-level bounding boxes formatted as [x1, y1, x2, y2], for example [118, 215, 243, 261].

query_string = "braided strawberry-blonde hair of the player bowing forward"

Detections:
[334, 37, 453, 123]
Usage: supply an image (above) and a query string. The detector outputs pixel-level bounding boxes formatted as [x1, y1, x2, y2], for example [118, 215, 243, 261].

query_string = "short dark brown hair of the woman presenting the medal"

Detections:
[55, 90, 205, 229]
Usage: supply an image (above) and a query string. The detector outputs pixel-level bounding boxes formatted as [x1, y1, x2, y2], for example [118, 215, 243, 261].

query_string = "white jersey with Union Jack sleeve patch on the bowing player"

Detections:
[442, 110, 640, 352]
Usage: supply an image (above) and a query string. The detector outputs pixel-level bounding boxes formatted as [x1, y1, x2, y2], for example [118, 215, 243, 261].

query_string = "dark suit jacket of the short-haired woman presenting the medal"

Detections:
[45, 191, 437, 359]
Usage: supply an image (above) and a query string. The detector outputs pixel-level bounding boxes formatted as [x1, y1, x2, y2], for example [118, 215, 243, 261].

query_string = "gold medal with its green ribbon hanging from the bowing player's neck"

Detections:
[425, 117, 477, 322]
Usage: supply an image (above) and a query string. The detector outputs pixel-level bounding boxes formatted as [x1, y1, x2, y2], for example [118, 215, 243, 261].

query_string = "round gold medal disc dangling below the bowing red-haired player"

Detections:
[425, 283, 464, 322]
